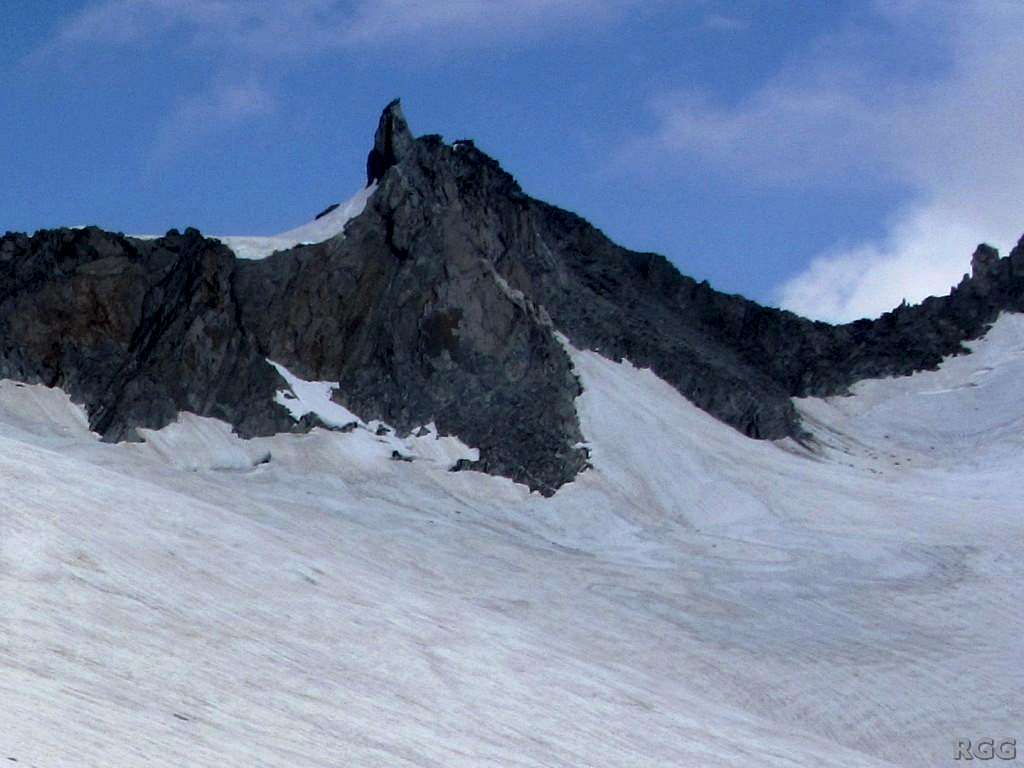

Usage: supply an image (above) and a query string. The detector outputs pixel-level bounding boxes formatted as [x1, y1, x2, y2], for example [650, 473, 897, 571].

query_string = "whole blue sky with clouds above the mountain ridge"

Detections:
[0, 0, 1024, 319]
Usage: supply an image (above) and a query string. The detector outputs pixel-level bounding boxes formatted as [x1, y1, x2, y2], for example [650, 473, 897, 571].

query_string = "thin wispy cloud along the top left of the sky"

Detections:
[41, 0, 647, 162]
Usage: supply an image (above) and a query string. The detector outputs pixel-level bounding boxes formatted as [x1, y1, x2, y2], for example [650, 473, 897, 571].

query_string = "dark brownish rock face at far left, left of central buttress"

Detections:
[0, 228, 292, 440]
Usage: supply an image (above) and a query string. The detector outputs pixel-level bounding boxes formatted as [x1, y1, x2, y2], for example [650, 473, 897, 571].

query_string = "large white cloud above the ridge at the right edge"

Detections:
[654, 0, 1024, 321]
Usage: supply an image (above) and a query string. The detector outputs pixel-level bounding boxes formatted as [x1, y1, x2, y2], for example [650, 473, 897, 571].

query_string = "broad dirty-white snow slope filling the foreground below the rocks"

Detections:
[0, 315, 1024, 768]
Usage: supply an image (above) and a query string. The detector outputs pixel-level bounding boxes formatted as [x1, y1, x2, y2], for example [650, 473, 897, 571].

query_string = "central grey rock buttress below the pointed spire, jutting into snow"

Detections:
[237, 132, 585, 493]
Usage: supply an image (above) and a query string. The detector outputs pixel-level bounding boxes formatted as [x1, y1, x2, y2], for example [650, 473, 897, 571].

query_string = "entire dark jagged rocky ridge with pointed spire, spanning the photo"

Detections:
[0, 101, 1024, 494]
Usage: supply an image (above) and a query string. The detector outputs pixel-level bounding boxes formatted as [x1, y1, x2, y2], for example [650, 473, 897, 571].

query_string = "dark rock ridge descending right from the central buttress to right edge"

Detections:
[503, 201, 1024, 438]
